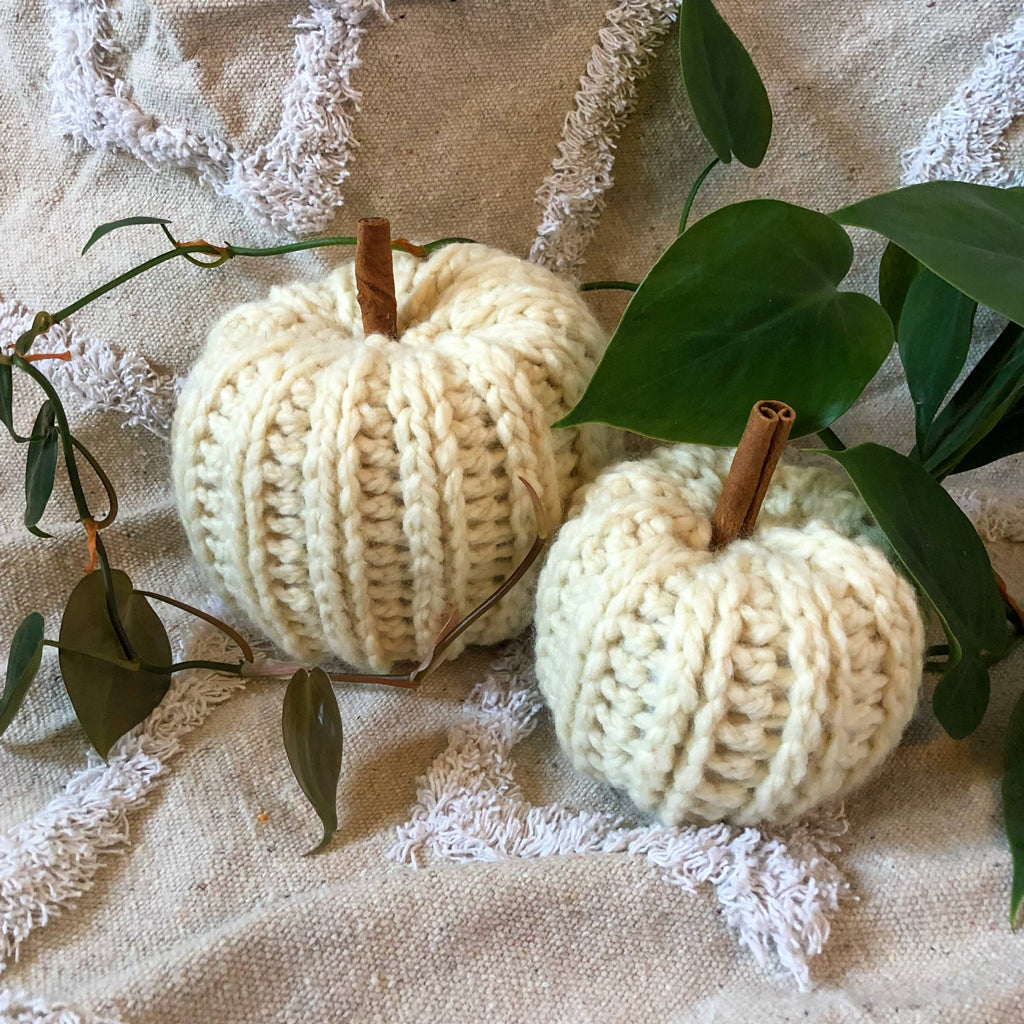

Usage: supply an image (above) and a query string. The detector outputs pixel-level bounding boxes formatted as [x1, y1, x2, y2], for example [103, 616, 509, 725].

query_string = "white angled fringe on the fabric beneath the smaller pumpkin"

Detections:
[388, 643, 847, 989]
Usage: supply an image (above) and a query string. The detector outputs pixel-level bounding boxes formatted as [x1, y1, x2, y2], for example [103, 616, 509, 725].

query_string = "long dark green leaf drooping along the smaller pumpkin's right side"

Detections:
[826, 444, 1008, 739]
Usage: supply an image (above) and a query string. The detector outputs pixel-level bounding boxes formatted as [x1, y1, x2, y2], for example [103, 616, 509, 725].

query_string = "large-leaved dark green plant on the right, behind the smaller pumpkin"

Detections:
[559, 0, 1024, 922]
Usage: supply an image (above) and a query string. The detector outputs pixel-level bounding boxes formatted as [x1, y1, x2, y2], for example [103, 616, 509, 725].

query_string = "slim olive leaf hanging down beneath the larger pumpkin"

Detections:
[282, 669, 342, 853]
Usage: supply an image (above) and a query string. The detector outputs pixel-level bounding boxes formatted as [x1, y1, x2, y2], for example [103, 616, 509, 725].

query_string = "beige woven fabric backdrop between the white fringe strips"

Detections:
[0, 0, 1024, 1024]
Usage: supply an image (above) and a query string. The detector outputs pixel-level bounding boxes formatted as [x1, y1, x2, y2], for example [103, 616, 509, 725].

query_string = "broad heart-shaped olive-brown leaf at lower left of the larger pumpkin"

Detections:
[59, 569, 171, 758]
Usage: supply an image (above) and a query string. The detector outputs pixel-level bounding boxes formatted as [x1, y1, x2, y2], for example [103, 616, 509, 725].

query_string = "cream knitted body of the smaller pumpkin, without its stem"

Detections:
[537, 446, 924, 825]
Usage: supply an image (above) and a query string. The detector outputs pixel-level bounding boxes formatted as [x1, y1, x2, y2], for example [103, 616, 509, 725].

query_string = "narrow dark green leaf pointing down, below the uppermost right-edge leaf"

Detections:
[897, 270, 978, 455]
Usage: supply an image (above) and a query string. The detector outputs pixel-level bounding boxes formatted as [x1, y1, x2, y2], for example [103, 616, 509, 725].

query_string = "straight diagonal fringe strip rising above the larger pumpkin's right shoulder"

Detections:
[529, 0, 679, 276]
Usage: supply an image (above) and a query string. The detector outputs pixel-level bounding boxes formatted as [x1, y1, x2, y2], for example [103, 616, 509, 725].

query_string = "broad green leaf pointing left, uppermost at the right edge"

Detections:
[833, 181, 1024, 322]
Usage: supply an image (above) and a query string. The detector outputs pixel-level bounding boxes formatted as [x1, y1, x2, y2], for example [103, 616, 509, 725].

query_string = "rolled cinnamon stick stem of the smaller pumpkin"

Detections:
[711, 401, 797, 550]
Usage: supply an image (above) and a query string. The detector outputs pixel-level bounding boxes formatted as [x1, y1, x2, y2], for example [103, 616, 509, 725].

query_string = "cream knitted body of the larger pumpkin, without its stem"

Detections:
[172, 245, 605, 671]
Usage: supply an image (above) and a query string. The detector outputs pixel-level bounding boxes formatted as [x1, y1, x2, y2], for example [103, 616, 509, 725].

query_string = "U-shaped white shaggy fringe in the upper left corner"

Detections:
[48, 0, 387, 234]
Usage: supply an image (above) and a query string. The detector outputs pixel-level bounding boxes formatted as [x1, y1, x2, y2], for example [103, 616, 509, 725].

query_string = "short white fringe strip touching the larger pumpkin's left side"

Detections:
[0, 299, 178, 439]
